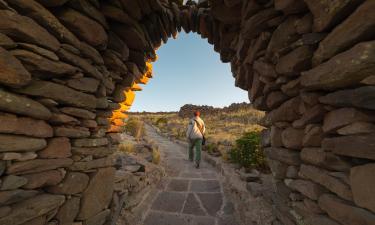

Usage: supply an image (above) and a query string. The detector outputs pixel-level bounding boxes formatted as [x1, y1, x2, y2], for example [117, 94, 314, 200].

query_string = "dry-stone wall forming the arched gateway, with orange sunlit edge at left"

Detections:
[0, 0, 375, 225]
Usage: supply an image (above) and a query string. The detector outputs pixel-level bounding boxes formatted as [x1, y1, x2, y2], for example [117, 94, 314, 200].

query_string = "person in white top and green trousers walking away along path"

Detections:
[186, 111, 206, 168]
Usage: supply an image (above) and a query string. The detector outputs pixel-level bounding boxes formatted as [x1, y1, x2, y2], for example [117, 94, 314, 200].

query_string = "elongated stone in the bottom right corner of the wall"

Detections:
[319, 194, 375, 225]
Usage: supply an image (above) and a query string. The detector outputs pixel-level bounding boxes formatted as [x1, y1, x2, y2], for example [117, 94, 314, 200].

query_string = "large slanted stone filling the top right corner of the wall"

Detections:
[310, 0, 375, 65]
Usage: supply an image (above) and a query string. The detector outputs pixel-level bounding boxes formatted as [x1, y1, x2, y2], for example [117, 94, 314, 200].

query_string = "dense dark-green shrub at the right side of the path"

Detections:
[230, 131, 267, 169]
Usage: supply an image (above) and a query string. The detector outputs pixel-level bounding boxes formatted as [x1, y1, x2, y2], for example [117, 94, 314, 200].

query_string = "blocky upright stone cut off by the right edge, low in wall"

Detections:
[350, 163, 375, 213]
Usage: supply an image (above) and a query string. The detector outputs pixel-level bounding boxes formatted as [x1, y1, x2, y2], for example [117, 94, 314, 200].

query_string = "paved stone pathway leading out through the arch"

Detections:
[143, 126, 237, 225]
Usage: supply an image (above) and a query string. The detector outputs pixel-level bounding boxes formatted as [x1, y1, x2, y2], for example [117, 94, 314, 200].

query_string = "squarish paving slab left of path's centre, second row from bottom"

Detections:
[151, 192, 187, 212]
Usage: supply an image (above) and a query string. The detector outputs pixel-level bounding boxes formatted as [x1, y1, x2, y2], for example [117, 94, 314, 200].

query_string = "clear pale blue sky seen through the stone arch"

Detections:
[130, 32, 249, 112]
